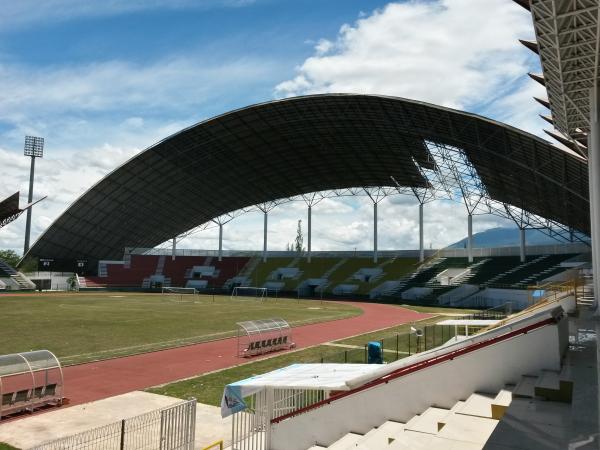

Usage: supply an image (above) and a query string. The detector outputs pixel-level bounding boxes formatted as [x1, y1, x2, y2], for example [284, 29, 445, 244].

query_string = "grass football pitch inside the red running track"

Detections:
[0, 292, 360, 364]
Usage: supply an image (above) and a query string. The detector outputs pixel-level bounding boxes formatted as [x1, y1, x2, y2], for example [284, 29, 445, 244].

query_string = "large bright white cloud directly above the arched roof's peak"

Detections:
[276, 0, 532, 112]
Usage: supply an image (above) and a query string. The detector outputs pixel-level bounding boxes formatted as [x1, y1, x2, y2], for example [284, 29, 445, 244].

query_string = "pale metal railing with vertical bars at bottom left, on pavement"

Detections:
[30, 399, 196, 450]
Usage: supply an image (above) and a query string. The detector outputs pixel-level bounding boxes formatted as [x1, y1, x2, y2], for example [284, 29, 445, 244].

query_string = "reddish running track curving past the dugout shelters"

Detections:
[64, 302, 430, 405]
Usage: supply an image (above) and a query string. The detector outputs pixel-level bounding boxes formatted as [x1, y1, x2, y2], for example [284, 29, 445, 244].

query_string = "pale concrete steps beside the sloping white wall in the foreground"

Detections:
[309, 370, 573, 450]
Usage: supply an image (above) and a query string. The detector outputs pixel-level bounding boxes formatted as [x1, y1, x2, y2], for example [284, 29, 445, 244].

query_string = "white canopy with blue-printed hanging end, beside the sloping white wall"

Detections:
[221, 364, 380, 417]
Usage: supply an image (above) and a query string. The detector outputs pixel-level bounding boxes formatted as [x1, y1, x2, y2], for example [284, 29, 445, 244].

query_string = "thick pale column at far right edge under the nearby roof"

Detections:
[588, 81, 600, 316]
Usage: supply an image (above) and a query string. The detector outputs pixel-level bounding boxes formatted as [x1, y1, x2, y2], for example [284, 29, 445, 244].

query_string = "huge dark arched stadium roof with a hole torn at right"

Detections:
[28, 94, 589, 259]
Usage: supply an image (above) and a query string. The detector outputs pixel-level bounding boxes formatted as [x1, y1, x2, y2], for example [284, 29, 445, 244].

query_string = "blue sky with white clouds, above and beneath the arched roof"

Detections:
[0, 0, 544, 250]
